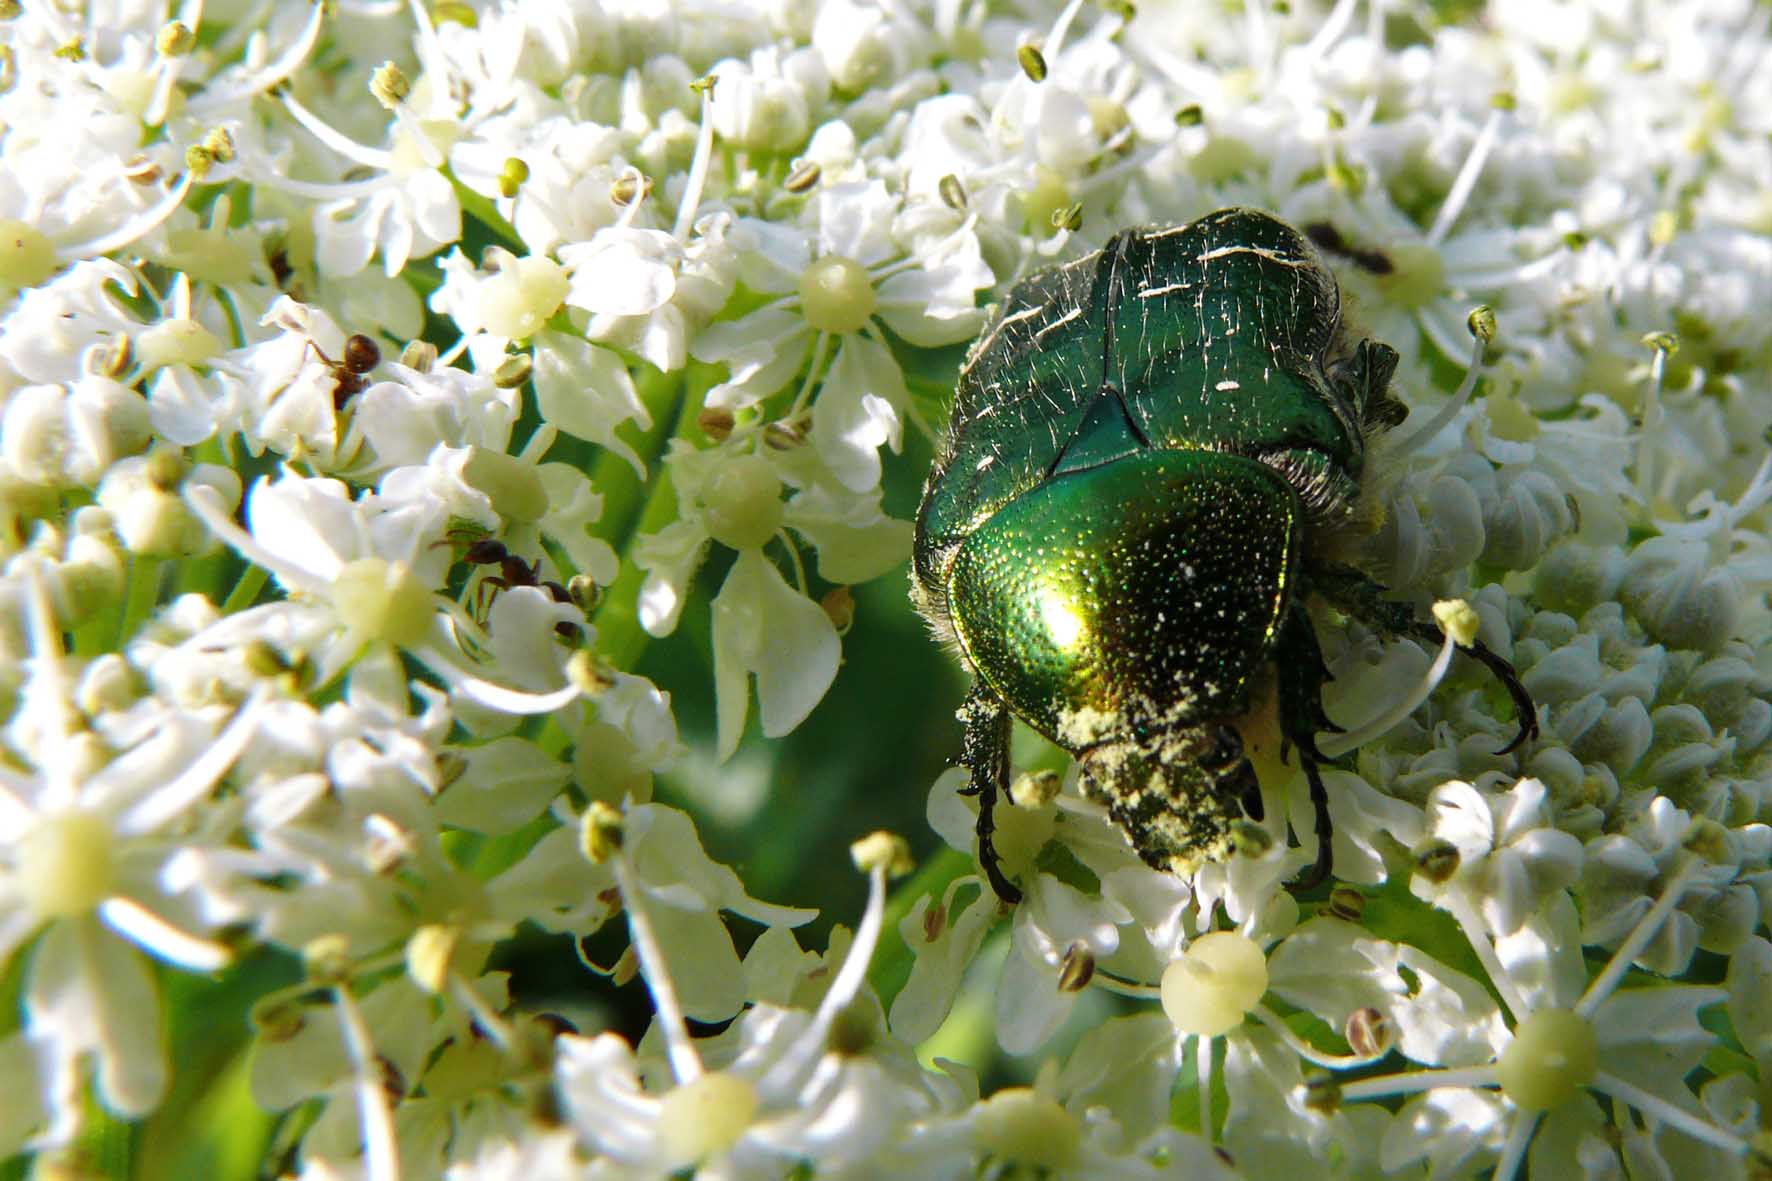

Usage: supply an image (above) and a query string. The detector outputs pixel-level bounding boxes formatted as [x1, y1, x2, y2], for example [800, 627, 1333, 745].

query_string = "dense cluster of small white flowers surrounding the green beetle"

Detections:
[0, 0, 1772, 1181]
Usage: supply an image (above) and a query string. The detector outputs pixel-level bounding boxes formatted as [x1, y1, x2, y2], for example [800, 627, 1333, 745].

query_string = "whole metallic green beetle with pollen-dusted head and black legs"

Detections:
[913, 209, 1536, 903]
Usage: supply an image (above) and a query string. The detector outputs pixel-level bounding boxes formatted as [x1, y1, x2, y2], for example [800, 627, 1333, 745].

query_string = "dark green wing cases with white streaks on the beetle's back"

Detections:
[914, 209, 1363, 592]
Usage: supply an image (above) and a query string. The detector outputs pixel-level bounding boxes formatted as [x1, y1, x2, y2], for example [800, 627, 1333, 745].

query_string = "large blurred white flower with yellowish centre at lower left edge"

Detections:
[0, 576, 242, 1144]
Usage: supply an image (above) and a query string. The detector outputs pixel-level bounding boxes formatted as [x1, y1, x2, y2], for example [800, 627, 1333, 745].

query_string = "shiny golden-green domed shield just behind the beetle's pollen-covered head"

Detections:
[948, 450, 1302, 750]
